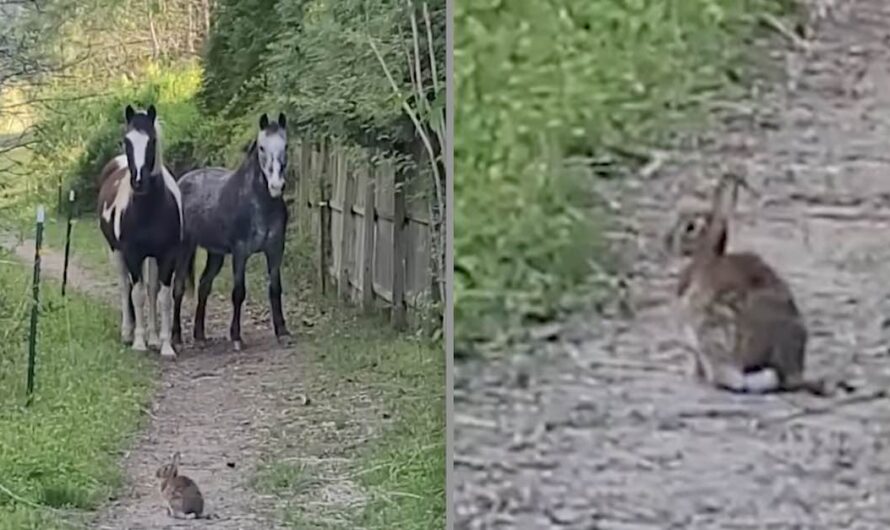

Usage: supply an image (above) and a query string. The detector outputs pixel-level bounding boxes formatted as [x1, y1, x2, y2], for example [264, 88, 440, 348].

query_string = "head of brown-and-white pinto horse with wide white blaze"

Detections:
[124, 105, 163, 195]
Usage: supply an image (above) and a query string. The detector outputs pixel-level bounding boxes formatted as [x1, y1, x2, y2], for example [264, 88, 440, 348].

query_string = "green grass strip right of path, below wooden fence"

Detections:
[316, 312, 445, 530]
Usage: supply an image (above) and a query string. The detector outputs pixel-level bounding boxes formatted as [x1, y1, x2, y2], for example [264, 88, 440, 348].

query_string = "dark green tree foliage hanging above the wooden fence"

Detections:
[201, 0, 445, 150]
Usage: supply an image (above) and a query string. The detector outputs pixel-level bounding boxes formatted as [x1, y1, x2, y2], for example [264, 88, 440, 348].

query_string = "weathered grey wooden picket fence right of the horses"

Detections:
[291, 140, 437, 328]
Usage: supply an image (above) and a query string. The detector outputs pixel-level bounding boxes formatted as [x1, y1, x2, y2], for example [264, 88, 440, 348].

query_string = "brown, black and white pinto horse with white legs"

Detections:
[98, 105, 184, 358]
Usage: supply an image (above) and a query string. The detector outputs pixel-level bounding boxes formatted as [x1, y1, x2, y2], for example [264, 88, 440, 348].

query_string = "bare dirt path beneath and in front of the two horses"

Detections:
[2, 238, 314, 530]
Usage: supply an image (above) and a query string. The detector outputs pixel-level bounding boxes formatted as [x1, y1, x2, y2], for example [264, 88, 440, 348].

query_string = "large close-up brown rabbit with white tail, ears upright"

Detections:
[672, 171, 828, 395]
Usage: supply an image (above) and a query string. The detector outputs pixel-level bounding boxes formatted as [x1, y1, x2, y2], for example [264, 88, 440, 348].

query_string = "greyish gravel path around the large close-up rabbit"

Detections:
[455, 0, 890, 529]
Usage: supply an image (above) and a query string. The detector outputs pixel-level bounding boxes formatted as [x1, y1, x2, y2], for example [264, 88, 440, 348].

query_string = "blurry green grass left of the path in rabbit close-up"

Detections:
[454, 0, 796, 347]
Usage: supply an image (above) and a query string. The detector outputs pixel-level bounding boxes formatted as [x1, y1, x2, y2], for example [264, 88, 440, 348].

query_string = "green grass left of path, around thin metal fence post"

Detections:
[0, 250, 155, 529]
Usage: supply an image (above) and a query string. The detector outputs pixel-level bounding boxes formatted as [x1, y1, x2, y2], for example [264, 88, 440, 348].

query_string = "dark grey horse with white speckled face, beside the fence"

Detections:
[173, 114, 289, 351]
